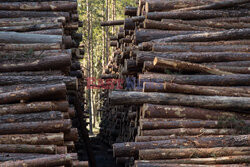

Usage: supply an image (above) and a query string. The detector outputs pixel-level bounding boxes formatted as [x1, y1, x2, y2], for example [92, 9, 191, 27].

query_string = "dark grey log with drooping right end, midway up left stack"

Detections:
[0, 75, 78, 90]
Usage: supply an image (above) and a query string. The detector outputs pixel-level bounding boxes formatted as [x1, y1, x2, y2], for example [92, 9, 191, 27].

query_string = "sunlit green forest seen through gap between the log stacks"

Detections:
[78, 0, 136, 134]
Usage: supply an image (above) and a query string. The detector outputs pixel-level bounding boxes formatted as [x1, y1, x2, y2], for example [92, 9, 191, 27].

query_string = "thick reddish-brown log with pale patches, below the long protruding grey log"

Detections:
[141, 104, 249, 120]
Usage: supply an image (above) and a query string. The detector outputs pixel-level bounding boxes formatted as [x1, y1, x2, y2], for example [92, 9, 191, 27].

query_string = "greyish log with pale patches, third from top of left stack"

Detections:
[0, 17, 66, 27]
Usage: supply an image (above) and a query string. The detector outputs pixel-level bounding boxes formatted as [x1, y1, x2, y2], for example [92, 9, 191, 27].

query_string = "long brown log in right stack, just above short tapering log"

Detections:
[145, 9, 249, 20]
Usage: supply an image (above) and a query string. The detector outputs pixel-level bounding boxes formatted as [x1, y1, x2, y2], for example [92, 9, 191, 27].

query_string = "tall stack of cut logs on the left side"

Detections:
[0, 0, 93, 167]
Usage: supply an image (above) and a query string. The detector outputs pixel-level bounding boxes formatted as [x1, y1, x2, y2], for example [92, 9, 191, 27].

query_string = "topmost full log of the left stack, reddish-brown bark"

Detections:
[0, 1, 77, 11]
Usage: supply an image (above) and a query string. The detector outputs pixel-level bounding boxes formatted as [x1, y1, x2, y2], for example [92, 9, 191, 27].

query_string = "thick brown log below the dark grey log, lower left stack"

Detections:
[0, 120, 71, 135]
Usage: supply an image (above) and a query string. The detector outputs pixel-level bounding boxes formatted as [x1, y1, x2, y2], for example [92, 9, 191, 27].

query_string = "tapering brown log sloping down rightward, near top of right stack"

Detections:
[143, 19, 219, 31]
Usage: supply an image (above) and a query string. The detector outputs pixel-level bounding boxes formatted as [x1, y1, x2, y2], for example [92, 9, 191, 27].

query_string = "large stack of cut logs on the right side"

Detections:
[101, 0, 250, 167]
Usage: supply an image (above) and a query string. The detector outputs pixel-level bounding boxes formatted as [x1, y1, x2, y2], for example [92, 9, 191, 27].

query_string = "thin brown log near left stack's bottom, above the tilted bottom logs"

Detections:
[0, 144, 62, 154]
